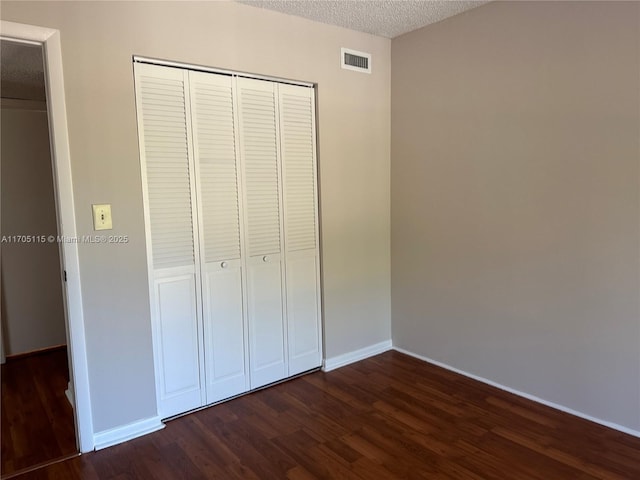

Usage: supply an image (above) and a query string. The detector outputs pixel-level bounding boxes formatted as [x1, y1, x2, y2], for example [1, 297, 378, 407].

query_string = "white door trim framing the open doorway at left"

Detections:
[0, 20, 94, 453]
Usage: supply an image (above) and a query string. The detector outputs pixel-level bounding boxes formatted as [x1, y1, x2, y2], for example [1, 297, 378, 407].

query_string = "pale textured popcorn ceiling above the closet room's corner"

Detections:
[236, 0, 488, 38]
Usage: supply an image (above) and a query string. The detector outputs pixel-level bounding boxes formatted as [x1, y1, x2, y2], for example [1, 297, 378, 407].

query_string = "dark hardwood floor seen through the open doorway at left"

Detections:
[0, 348, 77, 478]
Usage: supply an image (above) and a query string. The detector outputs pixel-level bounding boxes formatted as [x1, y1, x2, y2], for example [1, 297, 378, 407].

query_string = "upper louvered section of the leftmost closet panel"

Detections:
[136, 65, 195, 270]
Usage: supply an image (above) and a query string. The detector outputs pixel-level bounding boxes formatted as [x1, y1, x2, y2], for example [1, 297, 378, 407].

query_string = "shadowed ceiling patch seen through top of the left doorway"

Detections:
[0, 40, 46, 101]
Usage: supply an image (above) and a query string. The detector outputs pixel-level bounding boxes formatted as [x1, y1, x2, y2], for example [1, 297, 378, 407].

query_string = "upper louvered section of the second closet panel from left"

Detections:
[189, 72, 240, 262]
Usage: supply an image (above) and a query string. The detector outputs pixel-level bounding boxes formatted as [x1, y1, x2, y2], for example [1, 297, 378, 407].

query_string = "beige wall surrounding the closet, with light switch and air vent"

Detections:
[2, 1, 391, 431]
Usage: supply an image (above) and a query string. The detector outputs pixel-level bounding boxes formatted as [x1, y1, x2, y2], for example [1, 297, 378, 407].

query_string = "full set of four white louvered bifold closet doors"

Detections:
[135, 63, 322, 417]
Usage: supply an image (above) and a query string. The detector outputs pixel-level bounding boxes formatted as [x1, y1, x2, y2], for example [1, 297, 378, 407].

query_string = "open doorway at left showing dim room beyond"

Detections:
[0, 38, 78, 478]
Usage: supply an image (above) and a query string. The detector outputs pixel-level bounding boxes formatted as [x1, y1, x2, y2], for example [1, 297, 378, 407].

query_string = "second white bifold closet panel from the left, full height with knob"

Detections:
[189, 72, 249, 403]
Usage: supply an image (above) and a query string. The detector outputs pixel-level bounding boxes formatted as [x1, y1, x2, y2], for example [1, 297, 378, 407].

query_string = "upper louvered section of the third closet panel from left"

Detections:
[238, 78, 280, 256]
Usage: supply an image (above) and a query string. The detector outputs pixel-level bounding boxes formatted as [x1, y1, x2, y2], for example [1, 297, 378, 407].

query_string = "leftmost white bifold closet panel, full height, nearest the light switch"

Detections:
[135, 64, 204, 417]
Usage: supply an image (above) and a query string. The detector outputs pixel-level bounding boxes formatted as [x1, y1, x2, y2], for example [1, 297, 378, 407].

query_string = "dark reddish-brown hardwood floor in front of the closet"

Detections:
[10, 352, 640, 480]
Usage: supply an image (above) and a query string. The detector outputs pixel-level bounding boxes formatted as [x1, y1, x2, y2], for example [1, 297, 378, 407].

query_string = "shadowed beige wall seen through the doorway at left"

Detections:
[0, 107, 67, 355]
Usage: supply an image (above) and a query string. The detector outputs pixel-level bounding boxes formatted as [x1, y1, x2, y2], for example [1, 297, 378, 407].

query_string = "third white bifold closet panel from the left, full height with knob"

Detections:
[237, 78, 288, 388]
